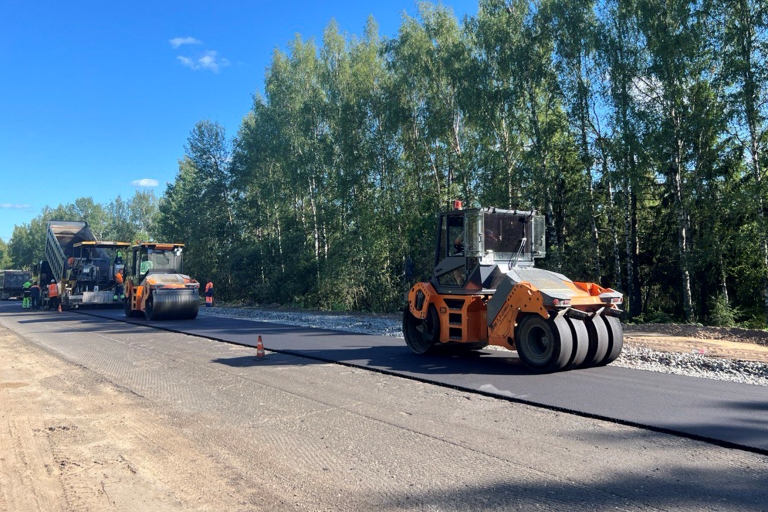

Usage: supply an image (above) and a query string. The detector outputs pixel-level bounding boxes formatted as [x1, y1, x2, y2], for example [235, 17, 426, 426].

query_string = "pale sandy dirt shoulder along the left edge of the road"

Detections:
[0, 327, 243, 512]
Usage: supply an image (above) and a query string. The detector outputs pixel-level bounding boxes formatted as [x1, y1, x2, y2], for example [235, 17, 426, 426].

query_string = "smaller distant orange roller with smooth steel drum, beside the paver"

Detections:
[124, 242, 200, 320]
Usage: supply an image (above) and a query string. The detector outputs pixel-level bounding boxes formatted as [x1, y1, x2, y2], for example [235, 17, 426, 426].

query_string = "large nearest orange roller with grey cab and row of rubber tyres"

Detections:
[403, 203, 623, 373]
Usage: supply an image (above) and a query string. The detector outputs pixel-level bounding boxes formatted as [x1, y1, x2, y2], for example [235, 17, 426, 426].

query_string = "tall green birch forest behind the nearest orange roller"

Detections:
[9, 0, 768, 327]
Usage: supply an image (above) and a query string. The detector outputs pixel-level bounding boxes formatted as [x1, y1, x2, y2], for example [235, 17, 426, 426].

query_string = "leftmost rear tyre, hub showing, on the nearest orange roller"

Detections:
[515, 315, 573, 373]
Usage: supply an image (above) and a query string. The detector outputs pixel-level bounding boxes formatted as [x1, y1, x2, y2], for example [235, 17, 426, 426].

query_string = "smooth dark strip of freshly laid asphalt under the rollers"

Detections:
[0, 303, 768, 454]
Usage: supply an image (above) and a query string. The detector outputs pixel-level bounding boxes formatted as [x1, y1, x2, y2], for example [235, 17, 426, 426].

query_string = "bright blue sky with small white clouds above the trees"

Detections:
[0, 0, 477, 242]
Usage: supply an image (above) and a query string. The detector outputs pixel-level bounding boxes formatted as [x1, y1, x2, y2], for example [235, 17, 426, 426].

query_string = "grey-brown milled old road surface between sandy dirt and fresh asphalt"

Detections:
[0, 305, 768, 511]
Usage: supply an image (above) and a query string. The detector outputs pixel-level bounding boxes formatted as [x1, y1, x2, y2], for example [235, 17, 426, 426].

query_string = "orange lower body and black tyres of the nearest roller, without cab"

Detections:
[403, 283, 623, 373]
